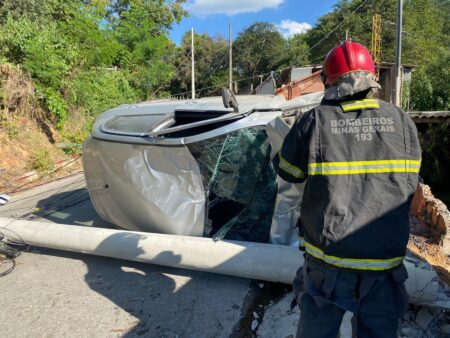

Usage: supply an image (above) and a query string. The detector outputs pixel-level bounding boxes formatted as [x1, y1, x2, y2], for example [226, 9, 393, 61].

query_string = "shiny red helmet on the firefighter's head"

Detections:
[323, 40, 375, 85]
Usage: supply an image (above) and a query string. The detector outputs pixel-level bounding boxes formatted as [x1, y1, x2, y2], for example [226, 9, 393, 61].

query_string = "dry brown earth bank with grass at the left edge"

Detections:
[0, 64, 81, 193]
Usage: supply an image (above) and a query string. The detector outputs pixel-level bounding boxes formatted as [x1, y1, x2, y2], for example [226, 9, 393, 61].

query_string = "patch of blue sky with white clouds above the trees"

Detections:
[170, 0, 337, 44]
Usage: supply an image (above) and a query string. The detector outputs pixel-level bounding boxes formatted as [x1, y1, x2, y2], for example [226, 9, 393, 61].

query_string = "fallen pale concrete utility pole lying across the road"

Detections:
[0, 218, 438, 305]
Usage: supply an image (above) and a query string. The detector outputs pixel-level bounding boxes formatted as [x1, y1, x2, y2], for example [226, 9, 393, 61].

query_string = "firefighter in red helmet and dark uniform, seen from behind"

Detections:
[274, 41, 421, 338]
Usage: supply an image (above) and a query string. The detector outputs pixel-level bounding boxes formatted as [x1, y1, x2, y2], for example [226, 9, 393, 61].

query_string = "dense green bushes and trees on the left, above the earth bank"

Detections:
[0, 0, 186, 139]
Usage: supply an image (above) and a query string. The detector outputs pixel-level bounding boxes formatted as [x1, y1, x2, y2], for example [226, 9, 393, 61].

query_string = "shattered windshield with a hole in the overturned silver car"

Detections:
[188, 127, 277, 242]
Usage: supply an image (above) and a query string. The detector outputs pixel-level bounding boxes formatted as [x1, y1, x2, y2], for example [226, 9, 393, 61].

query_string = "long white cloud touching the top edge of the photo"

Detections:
[186, 0, 284, 17]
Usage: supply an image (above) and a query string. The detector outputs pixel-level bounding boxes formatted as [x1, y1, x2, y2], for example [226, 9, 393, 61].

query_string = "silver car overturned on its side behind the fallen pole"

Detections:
[83, 93, 322, 244]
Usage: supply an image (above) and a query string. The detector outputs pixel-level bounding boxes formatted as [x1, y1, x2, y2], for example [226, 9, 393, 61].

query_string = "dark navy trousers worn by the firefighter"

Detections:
[294, 255, 408, 338]
